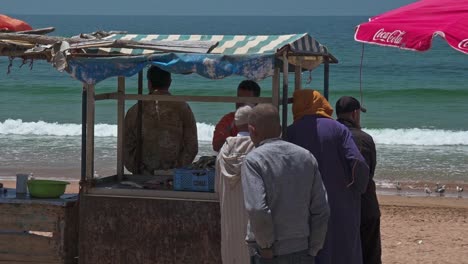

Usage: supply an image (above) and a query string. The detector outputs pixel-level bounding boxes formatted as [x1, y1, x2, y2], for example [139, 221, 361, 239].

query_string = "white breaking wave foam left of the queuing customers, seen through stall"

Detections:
[0, 119, 214, 141]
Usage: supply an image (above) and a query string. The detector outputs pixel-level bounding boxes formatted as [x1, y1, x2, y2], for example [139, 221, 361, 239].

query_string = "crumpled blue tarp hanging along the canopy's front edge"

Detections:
[68, 53, 274, 84]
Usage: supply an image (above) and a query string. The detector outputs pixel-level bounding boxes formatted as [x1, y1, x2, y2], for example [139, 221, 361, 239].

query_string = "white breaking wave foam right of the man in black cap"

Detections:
[364, 128, 468, 146]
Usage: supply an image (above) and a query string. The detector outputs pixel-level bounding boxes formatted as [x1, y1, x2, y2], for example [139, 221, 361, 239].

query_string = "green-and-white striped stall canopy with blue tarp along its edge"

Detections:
[68, 34, 337, 84]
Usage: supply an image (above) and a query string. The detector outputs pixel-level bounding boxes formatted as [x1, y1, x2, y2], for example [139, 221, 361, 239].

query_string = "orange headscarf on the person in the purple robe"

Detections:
[293, 89, 333, 121]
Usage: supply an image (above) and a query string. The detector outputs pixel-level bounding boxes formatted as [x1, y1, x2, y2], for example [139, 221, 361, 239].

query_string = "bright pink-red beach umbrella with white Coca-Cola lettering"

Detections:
[354, 0, 468, 54]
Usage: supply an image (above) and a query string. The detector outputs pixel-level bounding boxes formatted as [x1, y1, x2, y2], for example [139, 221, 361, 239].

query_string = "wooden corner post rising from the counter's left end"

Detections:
[85, 84, 95, 181]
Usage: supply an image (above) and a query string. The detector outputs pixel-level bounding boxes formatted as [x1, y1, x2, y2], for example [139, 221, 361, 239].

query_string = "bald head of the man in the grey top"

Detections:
[249, 104, 281, 146]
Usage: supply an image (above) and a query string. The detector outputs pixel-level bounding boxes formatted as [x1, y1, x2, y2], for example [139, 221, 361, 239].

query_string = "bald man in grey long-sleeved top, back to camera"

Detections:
[242, 104, 330, 264]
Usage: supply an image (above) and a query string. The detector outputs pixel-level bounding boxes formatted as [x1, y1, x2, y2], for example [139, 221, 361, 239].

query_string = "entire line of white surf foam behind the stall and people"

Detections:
[0, 119, 468, 146]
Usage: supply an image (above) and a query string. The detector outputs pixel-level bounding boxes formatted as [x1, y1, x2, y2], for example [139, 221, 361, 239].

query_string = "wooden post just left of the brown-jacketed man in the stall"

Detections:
[117, 76, 125, 181]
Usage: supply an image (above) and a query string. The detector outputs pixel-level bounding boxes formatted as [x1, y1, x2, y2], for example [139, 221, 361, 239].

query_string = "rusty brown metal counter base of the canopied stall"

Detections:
[79, 177, 221, 264]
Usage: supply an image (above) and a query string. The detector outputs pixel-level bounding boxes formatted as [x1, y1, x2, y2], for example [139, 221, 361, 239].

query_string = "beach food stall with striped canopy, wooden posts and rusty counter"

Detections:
[0, 29, 338, 264]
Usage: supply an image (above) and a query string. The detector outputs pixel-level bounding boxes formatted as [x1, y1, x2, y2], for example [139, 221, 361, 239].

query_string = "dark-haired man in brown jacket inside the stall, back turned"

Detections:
[124, 66, 198, 175]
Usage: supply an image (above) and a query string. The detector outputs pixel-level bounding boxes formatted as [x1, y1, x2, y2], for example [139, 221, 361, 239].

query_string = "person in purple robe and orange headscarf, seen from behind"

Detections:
[286, 90, 369, 264]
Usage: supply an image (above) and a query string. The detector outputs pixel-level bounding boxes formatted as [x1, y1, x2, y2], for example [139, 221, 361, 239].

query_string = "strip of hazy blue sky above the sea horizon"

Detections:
[4, 0, 416, 16]
